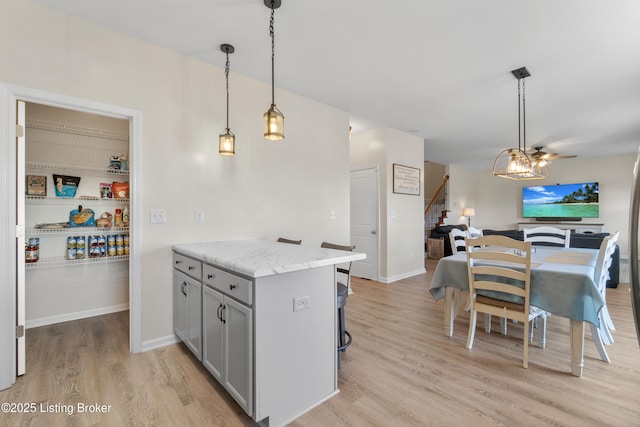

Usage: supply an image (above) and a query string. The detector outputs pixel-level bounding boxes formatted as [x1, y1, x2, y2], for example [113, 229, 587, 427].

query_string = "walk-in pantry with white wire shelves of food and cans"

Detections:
[23, 103, 130, 333]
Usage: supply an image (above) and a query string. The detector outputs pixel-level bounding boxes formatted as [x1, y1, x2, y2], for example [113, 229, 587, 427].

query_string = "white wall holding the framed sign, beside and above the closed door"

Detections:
[350, 128, 424, 282]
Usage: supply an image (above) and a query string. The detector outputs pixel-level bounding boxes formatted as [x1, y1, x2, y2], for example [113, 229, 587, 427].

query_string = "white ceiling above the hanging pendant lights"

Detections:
[33, 0, 640, 169]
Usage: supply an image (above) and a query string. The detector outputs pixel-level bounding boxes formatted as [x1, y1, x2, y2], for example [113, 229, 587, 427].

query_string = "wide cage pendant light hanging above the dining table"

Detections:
[493, 67, 549, 180]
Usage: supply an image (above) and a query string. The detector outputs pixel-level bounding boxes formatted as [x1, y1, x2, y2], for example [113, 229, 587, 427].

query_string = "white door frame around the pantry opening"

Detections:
[0, 82, 142, 390]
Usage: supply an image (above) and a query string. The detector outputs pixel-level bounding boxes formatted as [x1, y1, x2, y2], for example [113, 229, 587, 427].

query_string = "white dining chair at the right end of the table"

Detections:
[589, 231, 620, 363]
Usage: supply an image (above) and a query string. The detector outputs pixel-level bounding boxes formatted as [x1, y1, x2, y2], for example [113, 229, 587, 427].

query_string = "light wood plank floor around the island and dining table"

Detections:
[0, 261, 640, 427]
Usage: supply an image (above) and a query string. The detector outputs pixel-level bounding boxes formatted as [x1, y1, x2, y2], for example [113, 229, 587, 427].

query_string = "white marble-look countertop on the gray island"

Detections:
[172, 240, 366, 277]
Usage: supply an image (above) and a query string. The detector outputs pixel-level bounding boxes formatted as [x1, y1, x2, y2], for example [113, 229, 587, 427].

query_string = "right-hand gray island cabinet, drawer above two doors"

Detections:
[202, 264, 254, 416]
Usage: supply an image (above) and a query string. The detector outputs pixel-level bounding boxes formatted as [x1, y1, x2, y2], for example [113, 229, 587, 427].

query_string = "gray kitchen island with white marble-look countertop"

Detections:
[173, 240, 365, 426]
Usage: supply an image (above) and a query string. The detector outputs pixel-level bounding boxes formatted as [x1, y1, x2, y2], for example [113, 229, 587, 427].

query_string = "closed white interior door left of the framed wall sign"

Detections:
[351, 168, 380, 280]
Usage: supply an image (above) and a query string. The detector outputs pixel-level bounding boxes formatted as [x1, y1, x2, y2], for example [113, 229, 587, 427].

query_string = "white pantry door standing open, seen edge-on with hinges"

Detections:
[16, 101, 26, 375]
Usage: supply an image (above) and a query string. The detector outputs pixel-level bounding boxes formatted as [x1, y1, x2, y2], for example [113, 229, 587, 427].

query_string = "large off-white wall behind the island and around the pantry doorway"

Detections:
[0, 1, 349, 343]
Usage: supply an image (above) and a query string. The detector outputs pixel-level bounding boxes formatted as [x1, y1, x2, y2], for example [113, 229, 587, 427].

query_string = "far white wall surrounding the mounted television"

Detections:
[449, 153, 636, 270]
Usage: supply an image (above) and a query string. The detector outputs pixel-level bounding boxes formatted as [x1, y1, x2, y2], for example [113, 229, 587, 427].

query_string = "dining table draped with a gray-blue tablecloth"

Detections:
[429, 246, 605, 377]
